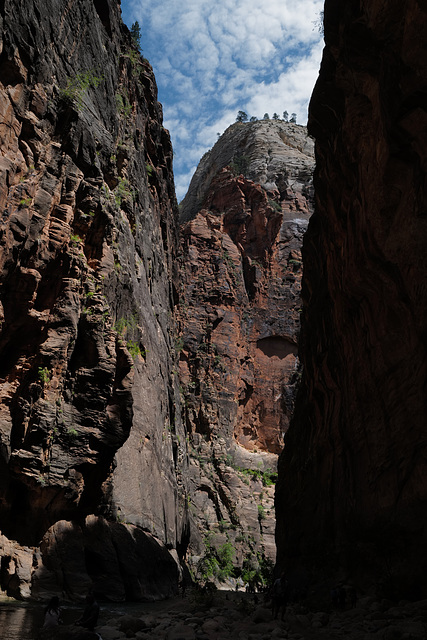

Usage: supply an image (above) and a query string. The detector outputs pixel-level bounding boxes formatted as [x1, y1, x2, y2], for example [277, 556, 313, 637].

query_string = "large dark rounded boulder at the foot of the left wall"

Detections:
[28, 516, 179, 602]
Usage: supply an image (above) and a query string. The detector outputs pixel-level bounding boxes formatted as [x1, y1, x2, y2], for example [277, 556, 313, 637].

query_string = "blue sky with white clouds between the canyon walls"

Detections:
[122, 0, 323, 201]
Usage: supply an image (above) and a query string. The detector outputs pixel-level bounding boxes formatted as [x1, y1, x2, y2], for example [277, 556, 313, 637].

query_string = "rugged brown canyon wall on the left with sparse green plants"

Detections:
[0, 0, 188, 599]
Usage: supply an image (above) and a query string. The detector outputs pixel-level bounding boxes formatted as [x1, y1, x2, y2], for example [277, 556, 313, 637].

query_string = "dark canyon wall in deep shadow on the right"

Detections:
[276, 0, 427, 595]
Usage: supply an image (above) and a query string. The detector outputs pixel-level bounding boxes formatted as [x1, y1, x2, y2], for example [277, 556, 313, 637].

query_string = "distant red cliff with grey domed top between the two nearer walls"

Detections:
[179, 121, 314, 575]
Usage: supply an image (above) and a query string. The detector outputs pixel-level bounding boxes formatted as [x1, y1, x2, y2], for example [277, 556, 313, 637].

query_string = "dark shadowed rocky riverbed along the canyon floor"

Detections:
[36, 592, 427, 640]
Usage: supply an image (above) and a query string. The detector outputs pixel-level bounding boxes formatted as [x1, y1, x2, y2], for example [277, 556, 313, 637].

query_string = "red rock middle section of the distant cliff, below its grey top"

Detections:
[181, 178, 300, 453]
